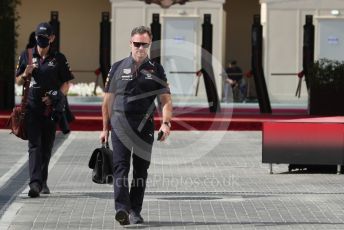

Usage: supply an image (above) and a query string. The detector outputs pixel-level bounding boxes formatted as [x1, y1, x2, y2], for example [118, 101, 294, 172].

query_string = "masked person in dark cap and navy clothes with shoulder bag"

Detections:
[16, 22, 73, 197]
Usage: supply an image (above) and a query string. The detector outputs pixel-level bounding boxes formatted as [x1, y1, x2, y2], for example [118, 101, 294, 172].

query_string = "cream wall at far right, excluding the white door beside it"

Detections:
[260, 0, 344, 104]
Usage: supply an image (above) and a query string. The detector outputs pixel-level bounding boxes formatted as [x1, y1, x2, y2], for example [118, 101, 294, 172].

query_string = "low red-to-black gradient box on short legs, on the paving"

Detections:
[262, 117, 344, 172]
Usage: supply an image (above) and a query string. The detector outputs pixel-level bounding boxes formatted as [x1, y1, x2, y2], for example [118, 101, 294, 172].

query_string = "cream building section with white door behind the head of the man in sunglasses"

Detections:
[110, 0, 225, 99]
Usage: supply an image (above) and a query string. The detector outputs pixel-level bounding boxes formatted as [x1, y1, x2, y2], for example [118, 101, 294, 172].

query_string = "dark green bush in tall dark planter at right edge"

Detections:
[308, 59, 344, 116]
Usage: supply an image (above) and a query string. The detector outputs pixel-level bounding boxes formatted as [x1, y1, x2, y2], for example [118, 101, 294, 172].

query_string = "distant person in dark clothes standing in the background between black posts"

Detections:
[224, 60, 246, 102]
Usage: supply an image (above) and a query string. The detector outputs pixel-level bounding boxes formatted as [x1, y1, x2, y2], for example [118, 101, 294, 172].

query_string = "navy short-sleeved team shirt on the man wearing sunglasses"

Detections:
[105, 55, 170, 115]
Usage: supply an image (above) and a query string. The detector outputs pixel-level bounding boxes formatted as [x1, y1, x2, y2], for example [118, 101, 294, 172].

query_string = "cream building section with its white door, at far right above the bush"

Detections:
[260, 0, 344, 103]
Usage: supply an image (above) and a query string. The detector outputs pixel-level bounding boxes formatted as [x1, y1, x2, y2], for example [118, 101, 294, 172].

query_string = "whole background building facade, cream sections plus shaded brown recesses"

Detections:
[17, 0, 344, 104]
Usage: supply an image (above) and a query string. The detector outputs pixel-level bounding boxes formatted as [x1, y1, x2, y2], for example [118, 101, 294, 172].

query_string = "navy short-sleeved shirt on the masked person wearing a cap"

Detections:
[16, 47, 74, 111]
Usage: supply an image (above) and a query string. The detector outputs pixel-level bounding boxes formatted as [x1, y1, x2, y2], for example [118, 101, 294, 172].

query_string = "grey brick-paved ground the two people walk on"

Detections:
[0, 130, 344, 230]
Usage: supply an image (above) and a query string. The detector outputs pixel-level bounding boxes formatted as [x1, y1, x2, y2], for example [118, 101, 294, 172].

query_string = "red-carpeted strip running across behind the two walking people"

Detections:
[0, 105, 309, 131]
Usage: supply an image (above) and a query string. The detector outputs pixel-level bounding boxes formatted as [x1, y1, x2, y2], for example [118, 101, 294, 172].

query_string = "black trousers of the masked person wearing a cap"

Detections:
[26, 111, 56, 186]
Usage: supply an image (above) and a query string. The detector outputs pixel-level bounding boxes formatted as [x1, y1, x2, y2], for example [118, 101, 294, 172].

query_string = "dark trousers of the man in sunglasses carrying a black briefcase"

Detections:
[111, 117, 154, 213]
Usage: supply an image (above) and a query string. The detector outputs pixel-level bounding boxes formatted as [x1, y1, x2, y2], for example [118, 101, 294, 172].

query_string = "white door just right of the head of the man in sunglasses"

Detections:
[161, 17, 200, 96]
